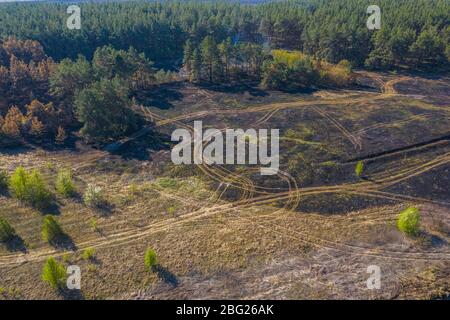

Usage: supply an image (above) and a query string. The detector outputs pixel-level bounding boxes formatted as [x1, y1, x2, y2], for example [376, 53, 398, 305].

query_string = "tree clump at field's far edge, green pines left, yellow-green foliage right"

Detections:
[183, 36, 352, 89]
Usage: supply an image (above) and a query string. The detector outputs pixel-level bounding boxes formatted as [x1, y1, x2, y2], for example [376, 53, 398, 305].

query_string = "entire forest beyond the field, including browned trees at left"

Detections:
[0, 0, 450, 146]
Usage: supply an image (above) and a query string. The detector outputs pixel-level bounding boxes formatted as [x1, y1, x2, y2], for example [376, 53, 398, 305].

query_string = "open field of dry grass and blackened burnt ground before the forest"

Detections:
[0, 73, 450, 299]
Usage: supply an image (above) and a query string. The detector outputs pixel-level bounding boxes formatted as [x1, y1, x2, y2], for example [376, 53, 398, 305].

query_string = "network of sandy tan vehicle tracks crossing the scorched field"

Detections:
[0, 78, 450, 267]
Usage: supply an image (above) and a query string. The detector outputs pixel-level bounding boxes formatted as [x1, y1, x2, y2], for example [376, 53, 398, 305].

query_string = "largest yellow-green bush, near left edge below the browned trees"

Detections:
[9, 167, 52, 209]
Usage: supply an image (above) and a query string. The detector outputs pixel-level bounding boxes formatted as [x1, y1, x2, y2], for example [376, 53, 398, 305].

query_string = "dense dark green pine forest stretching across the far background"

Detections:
[0, 0, 450, 69]
